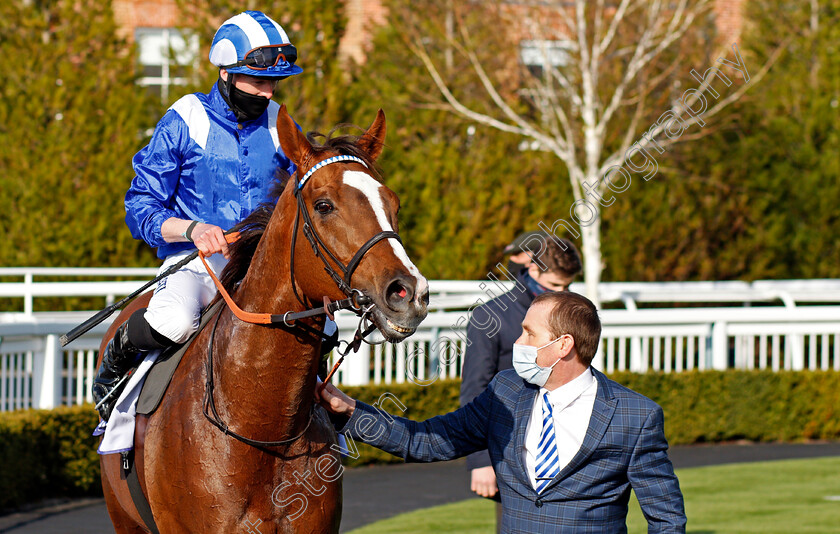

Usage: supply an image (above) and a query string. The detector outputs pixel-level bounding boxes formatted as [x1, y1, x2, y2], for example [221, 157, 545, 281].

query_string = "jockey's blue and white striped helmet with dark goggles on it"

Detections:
[210, 11, 303, 78]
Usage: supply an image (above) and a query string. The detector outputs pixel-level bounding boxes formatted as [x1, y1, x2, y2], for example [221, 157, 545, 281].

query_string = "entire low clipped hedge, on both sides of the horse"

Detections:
[0, 371, 840, 510]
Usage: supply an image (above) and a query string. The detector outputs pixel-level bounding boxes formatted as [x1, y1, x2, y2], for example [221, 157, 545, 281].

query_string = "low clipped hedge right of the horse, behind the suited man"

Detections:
[344, 371, 840, 466]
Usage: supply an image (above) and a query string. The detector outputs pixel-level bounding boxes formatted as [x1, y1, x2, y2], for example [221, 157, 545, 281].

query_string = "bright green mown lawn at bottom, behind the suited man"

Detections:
[350, 457, 840, 534]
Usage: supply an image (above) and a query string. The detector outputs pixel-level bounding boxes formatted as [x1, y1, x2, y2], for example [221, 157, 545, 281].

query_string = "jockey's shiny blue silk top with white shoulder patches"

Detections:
[125, 84, 296, 259]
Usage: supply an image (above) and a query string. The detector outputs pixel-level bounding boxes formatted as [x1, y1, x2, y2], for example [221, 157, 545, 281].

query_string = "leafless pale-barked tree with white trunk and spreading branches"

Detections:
[398, 0, 781, 299]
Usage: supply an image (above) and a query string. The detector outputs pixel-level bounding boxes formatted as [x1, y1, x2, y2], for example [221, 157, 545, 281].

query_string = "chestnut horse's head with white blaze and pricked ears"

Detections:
[277, 106, 429, 342]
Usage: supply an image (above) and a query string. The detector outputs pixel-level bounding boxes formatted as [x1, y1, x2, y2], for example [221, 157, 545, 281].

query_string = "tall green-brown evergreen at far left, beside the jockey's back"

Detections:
[0, 0, 155, 266]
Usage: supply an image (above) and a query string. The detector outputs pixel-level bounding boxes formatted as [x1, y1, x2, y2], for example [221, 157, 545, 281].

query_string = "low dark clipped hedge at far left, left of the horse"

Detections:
[0, 405, 102, 510]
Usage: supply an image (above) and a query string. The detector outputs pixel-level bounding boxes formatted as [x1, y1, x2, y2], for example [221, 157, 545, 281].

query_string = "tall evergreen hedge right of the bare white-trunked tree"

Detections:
[605, 0, 840, 280]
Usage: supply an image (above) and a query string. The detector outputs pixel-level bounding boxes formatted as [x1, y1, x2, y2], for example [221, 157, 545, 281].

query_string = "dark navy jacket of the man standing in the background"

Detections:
[461, 269, 534, 469]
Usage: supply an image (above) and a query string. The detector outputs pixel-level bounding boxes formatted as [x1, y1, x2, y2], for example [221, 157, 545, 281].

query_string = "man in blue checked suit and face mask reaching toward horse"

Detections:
[318, 292, 686, 534]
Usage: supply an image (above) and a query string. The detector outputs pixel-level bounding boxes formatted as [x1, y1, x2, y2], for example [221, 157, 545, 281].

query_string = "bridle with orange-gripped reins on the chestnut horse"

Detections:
[199, 155, 402, 447]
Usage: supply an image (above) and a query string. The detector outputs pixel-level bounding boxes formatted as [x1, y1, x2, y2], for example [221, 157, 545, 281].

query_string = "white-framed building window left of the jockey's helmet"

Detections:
[134, 28, 198, 104]
